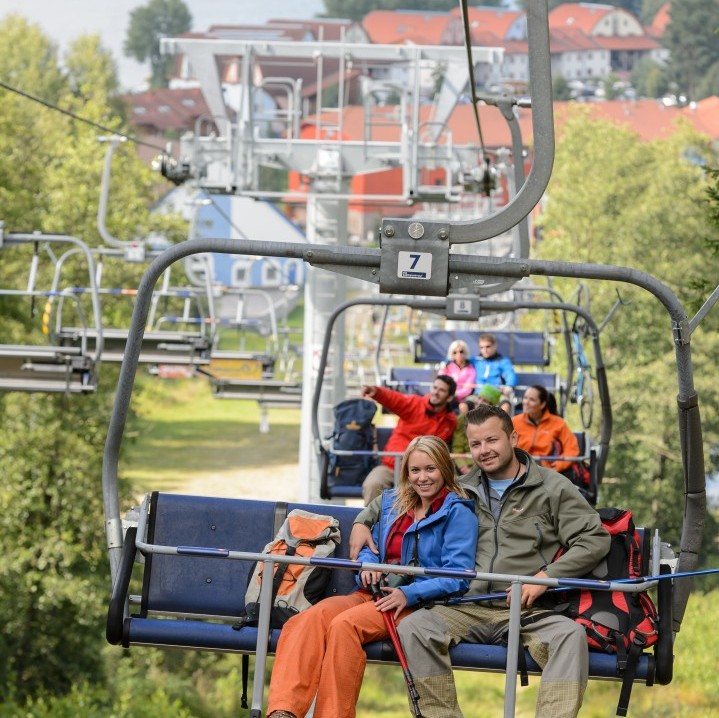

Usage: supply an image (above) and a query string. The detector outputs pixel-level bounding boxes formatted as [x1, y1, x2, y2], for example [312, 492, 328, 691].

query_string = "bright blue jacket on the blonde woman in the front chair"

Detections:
[357, 489, 478, 606]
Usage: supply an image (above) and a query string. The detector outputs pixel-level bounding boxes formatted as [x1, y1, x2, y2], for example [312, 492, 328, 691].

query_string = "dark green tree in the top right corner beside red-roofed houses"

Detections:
[662, 0, 719, 100]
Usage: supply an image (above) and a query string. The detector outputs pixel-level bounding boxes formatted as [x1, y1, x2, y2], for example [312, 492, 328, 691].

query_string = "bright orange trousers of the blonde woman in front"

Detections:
[267, 591, 412, 718]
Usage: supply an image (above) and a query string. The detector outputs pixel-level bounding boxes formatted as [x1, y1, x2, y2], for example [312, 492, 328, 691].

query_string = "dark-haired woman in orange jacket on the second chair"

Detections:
[512, 385, 579, 473]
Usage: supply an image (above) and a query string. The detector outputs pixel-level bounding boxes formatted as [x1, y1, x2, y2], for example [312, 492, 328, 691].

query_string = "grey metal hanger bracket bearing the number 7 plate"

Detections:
[379, 219, 450, 297]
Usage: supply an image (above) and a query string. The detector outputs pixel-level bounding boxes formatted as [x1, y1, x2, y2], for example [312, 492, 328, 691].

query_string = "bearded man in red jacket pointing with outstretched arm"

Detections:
[362, 375, 457, 505]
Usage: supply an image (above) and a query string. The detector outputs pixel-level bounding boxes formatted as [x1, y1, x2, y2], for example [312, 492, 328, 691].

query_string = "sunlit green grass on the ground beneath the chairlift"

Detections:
[128, 380, 719, 718]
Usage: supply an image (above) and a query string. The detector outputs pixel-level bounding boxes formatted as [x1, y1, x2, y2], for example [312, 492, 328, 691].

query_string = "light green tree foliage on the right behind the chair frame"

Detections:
[539, 108, 719, 548]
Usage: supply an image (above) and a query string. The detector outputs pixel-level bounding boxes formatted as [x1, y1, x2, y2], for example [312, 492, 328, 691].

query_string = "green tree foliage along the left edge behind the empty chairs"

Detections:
[0, 16, 180, 704]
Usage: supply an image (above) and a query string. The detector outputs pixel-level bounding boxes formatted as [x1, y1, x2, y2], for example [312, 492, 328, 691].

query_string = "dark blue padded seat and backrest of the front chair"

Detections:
[106, 492, 671, 708]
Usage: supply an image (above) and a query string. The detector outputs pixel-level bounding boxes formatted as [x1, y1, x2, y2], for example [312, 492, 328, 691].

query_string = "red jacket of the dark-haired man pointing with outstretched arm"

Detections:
[373, 386, 457, 469]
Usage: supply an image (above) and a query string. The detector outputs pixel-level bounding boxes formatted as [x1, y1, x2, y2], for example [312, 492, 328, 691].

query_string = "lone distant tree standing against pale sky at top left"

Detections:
[123, 0, 192, 87]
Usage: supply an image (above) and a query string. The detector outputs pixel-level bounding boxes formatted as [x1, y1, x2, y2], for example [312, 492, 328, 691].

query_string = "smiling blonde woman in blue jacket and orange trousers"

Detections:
[268, 436, 478, 718]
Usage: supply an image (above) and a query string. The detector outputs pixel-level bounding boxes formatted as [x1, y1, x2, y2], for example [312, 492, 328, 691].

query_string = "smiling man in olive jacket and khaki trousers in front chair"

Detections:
[350, 405, 610, 718]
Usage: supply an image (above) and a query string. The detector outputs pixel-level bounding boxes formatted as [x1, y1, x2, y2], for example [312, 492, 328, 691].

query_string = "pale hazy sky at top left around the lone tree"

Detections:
[0, 0, 324, 90]
